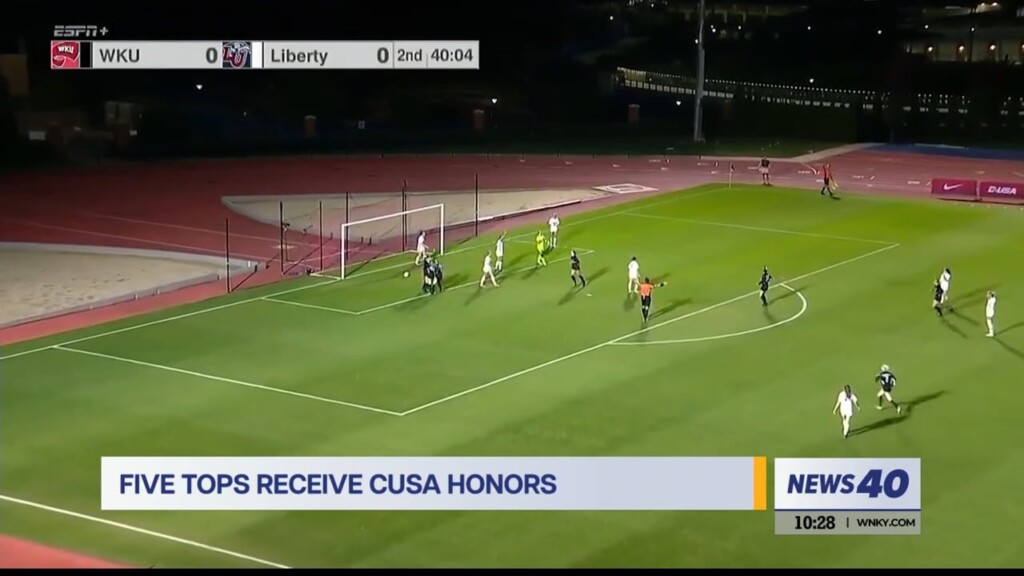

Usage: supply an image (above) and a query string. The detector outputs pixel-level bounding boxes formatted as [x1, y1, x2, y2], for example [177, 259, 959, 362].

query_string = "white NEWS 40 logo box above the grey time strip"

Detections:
[775, 458, 921, 511]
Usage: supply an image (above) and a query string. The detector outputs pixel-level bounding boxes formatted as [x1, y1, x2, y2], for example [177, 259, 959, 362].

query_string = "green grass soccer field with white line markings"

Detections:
[0, 186, 1024, 567]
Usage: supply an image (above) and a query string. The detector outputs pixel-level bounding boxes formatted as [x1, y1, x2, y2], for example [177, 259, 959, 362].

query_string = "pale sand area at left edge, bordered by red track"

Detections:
[0, 244, 234, 326]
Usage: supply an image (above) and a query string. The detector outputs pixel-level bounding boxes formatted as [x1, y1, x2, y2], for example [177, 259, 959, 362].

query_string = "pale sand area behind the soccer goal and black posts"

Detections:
[223, 188, 614, 239]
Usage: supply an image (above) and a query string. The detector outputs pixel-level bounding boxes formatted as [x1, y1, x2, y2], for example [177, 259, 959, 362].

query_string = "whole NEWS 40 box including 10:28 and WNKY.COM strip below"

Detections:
[774, 458, 921, 535]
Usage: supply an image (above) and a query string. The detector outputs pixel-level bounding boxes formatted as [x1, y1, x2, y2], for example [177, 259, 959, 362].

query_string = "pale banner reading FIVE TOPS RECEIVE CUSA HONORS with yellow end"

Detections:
[100, 457, 767, 510]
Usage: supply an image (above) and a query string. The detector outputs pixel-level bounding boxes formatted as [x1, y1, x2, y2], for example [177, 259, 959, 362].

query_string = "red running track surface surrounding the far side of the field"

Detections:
[0, 150, 1024, 343]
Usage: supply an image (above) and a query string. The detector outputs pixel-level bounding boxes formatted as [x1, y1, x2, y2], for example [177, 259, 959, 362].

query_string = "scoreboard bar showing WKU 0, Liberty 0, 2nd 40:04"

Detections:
[50, 36, 480, 70]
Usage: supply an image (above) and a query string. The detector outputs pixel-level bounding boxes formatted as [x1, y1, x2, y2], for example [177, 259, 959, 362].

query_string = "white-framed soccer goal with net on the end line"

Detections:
[316, 204, 444, 280]
